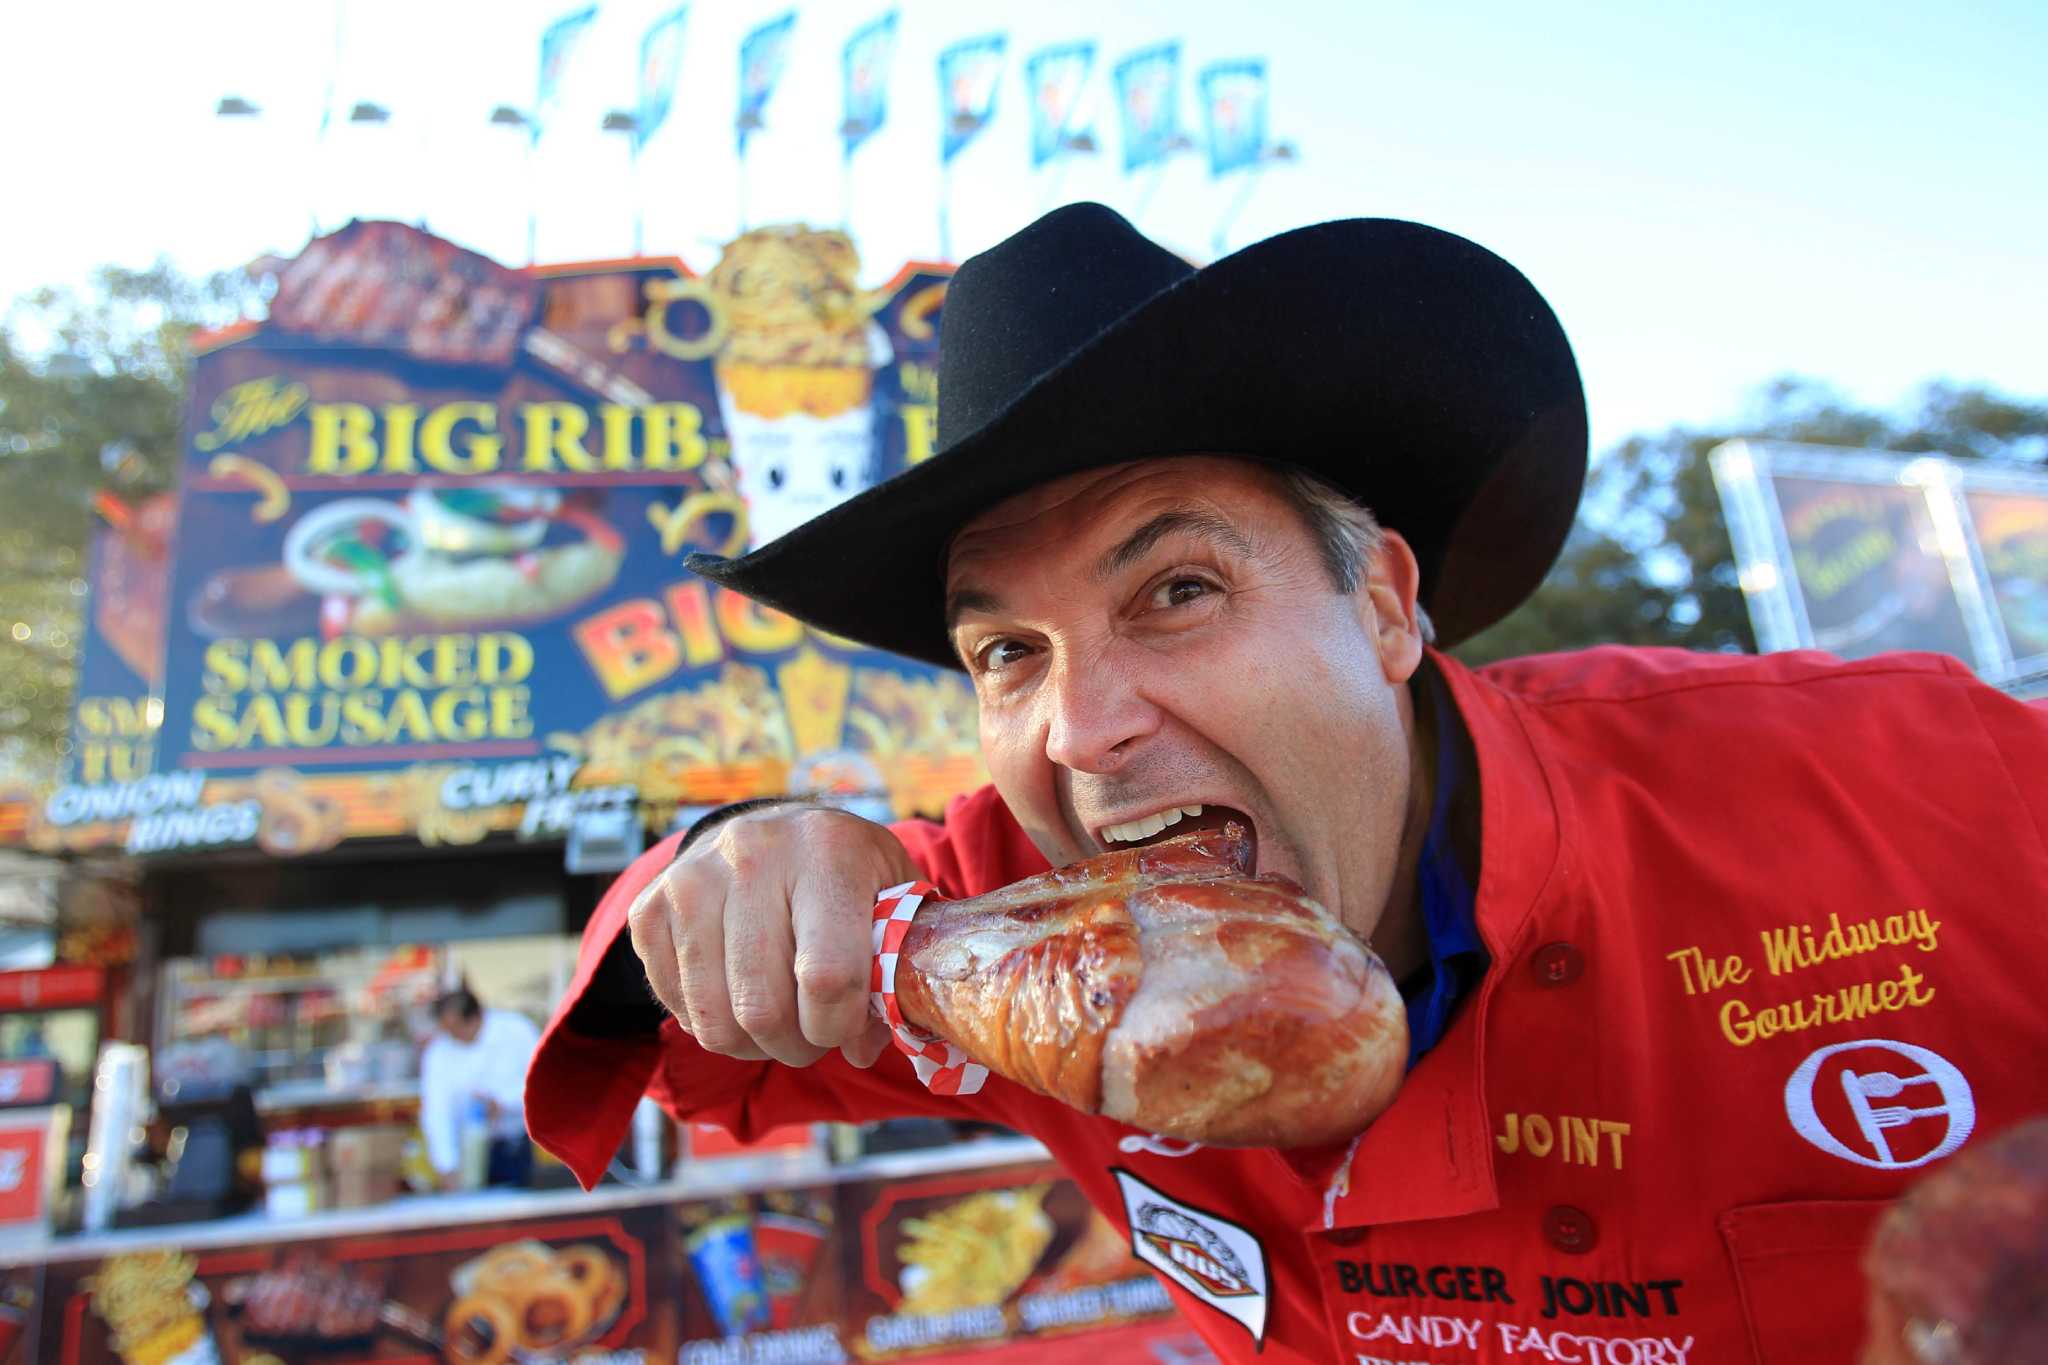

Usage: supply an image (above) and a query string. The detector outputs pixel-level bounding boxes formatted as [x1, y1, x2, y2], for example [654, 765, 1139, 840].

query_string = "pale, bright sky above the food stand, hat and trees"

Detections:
[0, 0, 2048, 448]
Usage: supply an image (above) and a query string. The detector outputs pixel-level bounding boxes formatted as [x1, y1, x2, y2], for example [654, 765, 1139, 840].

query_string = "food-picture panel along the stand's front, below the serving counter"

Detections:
[39, 1162, 1204, 1365]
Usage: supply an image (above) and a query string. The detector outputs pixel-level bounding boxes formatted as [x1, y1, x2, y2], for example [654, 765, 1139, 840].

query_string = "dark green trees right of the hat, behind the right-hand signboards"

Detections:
[1456, 379, 2048, 663]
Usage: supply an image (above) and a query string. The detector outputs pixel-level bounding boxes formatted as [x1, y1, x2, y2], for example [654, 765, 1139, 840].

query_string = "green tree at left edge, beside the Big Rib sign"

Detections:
[0, 262, 250, 778]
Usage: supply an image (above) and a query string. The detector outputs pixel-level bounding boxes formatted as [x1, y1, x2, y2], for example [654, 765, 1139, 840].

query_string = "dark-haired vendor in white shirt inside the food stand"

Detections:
[420, 986, 541, 1189]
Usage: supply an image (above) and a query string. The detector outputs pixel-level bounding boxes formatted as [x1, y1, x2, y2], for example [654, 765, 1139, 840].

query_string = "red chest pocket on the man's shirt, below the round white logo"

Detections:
[1720, 1199, 1886, 1365]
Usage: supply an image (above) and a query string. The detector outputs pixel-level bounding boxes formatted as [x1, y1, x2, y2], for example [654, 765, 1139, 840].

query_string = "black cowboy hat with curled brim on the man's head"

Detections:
[688, 205, 1585, 667]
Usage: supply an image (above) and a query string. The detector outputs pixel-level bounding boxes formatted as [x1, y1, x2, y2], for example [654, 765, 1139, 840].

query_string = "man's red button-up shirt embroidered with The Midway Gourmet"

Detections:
[526, 649, 2048, 1365]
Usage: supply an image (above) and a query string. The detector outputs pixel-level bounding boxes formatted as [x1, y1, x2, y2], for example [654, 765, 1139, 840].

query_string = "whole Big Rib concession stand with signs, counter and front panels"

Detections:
[0, 221, 1204, 1365]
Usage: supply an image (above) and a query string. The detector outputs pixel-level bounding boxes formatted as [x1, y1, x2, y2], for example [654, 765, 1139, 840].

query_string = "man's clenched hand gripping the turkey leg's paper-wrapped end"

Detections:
[627, 804, 918, 1066]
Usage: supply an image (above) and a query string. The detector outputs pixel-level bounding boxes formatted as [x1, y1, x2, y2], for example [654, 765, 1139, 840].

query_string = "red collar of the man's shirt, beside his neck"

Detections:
[1313, 651, 1567, 1228]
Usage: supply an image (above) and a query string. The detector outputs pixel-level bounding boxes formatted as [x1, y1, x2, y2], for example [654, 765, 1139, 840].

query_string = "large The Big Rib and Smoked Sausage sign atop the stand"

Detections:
[29, 221, 981, 855]
